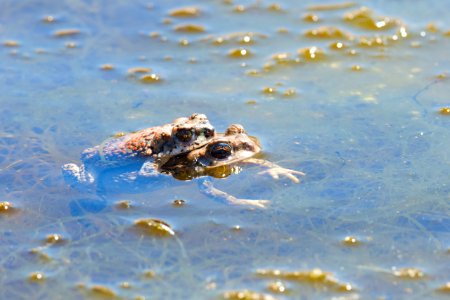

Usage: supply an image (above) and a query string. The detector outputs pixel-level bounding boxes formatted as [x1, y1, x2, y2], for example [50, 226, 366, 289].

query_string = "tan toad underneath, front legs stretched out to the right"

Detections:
[160, 124, 305, 208]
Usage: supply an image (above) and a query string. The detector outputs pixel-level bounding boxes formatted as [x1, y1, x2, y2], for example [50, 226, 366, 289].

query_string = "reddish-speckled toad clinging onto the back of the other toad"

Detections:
[62, 114, 215, 183]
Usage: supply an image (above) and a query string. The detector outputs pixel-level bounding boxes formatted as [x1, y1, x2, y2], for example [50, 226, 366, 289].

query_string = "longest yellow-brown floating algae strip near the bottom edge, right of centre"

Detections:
[256, 269, 354, 292]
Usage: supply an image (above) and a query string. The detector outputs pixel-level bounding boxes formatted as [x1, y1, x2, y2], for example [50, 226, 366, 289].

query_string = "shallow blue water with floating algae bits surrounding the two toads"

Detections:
[0, 0, 450, 299]
